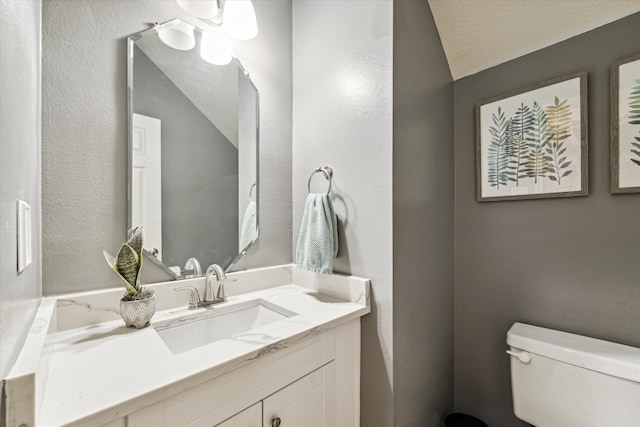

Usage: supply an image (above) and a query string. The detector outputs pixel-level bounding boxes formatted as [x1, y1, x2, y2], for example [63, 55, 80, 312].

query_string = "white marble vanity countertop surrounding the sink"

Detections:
[30, 267, 370, 426]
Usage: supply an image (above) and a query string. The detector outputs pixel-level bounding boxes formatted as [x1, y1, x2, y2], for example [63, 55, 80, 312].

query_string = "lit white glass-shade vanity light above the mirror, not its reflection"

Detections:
[176, 0, 258, 40]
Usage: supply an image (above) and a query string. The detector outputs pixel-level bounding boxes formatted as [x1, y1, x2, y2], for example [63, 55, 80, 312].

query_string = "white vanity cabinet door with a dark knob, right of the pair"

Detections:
[262, 362, 335, 427]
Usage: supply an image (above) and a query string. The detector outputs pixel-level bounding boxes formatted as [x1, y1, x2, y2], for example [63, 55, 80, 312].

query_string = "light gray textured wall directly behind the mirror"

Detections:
[42, 0, 292, 295]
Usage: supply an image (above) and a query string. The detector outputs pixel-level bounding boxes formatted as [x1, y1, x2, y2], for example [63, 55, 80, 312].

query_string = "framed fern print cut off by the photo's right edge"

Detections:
[610, 53, 640, 194]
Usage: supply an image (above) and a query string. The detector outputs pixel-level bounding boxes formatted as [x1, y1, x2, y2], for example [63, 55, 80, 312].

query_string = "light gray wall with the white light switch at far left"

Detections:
[0, 1, 42, 382]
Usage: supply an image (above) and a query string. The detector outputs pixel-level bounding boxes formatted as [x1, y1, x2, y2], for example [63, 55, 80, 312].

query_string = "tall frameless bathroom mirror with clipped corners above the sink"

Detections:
[127, 19, 259, 279]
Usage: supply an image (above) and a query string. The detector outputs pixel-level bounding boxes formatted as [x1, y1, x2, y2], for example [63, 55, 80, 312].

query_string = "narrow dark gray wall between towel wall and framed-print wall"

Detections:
[393, 0, 453, 427]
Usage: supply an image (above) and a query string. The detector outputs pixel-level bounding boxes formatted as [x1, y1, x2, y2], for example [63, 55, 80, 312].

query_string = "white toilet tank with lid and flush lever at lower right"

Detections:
[507, 323, 640, 427]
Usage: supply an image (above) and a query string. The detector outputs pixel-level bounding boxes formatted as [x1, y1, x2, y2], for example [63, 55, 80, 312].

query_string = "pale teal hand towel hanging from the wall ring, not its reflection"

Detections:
[296, 194, 338, 274]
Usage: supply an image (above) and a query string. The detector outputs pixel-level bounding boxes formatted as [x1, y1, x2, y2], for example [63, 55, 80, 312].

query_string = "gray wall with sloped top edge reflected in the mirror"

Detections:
[131, 47, 238, 269]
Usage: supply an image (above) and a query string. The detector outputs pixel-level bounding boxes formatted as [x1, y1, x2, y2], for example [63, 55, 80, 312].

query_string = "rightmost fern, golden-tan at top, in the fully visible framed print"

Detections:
[543, 96, 573, 185]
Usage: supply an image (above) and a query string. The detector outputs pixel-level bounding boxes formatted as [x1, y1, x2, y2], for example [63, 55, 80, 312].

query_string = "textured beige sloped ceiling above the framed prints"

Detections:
[428, 0, 640, 80]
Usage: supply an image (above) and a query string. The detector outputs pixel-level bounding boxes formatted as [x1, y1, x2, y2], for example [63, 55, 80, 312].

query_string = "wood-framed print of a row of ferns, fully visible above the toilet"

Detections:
[476, 71, 589, 202]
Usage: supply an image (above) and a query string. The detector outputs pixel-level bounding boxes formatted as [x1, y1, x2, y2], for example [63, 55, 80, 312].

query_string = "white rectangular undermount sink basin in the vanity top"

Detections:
[153, 300, 296, 354]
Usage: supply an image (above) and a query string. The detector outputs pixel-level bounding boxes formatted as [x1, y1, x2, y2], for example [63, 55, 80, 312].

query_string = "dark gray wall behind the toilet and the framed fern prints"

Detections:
[454, 14, 640, 427]
